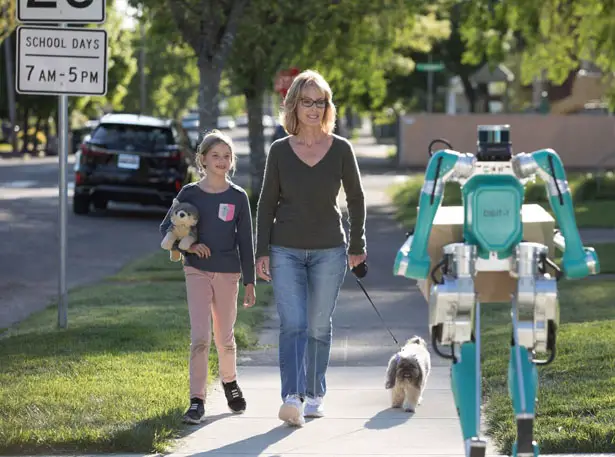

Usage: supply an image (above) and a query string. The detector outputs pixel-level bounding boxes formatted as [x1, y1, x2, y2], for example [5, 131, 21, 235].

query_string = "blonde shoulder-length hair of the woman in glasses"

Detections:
[280, 70, 337, 135]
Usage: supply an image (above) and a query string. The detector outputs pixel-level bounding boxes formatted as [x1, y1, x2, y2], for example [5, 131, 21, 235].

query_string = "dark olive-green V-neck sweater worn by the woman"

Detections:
[256, 135, 366, 257]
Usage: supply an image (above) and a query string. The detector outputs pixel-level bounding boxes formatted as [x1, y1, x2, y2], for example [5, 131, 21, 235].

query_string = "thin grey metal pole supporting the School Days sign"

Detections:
[57, 23, 68, 328]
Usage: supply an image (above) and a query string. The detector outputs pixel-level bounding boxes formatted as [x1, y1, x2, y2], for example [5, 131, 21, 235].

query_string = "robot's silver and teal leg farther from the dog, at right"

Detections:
[508, 242, 559, 457]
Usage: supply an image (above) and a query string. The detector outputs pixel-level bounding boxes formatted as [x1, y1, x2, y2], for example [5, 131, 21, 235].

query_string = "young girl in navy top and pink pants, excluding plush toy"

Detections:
[160, 130, 256, 424]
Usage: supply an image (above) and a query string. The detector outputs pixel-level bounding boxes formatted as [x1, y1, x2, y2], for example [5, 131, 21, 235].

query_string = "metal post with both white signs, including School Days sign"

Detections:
[15, 0, 107, 328]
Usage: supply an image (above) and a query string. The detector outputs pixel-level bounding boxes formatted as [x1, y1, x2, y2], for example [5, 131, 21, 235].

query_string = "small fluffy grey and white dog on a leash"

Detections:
[385, 336, 431, 412]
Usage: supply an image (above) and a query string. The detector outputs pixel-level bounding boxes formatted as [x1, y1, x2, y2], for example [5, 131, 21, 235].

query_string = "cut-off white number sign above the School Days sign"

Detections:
[16, 0, 106, 24]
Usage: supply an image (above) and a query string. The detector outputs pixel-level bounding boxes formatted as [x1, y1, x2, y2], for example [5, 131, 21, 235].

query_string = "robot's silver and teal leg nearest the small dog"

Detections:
[429, 243, 487, 457]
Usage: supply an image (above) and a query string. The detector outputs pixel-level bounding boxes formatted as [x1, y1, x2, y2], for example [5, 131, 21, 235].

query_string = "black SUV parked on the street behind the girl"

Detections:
[73, 114, 194, 214]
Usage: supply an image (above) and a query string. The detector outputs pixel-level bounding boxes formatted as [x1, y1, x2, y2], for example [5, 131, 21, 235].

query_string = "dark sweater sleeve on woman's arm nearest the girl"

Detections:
[256, 146, 280, 258]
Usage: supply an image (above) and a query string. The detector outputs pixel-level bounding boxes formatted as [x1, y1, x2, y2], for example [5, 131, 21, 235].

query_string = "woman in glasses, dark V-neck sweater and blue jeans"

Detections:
[256, 71, 367, 426]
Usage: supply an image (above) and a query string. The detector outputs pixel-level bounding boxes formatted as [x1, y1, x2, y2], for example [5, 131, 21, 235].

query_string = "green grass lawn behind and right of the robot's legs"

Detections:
[481, 280, 615, 455]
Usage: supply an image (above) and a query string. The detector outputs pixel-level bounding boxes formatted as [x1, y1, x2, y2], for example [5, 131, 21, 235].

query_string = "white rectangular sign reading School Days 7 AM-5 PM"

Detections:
[16, 26, 107, 96]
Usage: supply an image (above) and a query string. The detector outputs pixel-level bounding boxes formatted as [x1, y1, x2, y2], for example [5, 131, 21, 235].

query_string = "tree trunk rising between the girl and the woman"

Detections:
[244, 75, 266, 202]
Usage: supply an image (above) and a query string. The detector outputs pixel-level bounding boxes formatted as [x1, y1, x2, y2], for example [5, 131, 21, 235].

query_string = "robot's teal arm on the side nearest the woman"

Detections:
[396, 149, 475, 279]
